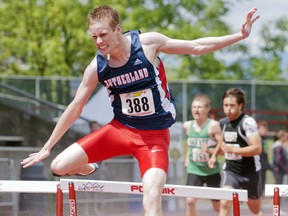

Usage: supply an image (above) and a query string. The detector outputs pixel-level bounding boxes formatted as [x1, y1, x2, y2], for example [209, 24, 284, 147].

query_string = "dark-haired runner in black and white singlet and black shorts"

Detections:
[220, 88, 263, 216]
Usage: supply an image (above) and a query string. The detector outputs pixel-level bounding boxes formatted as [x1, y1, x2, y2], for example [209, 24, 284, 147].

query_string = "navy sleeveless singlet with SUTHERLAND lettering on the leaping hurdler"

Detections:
[96, 30, 176, 130]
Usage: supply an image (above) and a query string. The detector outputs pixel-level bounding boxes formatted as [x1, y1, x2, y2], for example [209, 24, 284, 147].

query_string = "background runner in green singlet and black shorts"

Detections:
[183, 94, 223, 216]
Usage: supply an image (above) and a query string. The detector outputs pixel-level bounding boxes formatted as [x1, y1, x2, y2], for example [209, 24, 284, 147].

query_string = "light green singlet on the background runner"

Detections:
[187, 119, 220, 176]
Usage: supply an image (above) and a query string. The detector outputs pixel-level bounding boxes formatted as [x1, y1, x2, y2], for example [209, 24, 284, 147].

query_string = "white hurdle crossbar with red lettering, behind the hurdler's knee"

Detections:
[60, 179, 248, 202]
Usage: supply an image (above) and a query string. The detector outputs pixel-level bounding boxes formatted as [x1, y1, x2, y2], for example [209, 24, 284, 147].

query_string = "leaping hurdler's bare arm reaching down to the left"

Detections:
[21, 60, 98, 168]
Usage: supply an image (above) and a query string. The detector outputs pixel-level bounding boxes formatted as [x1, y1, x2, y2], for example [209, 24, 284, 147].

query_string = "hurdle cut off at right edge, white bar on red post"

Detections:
[265, 184, 288, 216]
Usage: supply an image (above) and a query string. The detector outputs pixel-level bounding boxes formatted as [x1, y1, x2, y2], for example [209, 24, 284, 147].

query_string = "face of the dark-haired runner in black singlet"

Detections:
[223, 96, 243, 121]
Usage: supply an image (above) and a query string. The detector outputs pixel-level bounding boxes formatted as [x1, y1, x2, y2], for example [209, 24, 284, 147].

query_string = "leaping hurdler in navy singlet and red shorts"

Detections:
[22, 6, 259, 216]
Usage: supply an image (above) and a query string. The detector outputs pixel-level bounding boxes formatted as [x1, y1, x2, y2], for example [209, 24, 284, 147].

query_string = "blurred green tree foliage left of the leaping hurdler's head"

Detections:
[0, 0, 96, 76]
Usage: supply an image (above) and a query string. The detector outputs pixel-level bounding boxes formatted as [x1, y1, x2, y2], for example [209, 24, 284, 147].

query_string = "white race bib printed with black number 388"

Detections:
[120, 89, 155, 116]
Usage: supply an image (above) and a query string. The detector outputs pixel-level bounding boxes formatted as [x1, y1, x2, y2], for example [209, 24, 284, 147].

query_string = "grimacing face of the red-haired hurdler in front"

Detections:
[89, 20, 122, 55]
